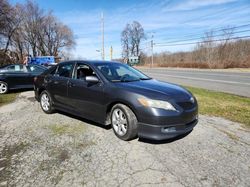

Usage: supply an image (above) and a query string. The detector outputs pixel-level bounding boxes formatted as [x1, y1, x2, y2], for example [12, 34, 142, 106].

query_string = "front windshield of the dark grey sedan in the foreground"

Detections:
[95, 62, 151, 82]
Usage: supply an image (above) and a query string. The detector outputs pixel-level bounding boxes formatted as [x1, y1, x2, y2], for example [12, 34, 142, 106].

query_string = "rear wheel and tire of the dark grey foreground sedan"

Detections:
[40, 90, 54, 114]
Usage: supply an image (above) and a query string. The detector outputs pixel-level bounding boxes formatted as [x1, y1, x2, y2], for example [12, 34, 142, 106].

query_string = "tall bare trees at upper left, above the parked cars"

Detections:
[0, 0, 75, 65]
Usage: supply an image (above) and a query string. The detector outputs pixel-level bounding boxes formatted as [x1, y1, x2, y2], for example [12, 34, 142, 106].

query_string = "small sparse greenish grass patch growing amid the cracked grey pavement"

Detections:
[48, 124, 85, 135]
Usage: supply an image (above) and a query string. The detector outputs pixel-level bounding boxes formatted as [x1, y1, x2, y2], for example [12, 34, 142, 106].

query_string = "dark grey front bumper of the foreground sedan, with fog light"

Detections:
[138, 104, 198, 140]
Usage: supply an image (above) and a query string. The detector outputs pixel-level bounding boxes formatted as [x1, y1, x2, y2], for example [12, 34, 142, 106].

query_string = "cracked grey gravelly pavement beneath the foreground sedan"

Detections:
[0, 92, 250, 187]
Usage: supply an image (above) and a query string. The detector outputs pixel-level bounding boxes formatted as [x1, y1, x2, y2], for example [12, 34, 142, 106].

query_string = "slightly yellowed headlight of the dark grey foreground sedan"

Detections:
[137, 97, 177, 111]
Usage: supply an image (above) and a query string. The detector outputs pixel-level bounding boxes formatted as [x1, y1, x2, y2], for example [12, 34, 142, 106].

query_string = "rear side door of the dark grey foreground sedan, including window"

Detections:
[46, 63, 74, 109]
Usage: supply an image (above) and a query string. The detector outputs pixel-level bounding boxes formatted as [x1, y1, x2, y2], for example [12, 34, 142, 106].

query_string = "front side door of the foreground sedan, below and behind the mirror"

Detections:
[68, 63, 106, 122]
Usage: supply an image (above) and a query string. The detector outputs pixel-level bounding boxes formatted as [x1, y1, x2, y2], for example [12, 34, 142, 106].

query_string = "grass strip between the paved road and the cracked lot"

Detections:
[185, 86, 250, 127]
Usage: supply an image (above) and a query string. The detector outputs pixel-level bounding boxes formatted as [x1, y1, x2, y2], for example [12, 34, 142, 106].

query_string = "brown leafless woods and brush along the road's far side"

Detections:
[141, 29, 250, 68]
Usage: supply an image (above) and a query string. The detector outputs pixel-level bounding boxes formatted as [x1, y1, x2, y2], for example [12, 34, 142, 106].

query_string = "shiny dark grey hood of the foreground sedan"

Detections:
[115, 79, 192, 100]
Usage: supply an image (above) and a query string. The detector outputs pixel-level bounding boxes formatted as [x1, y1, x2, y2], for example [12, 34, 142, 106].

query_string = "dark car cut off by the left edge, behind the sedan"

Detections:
[0, 64, 47, 94]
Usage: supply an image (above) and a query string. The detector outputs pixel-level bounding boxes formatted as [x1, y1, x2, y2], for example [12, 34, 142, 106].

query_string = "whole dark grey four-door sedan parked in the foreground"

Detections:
[34, 61, 198, 140]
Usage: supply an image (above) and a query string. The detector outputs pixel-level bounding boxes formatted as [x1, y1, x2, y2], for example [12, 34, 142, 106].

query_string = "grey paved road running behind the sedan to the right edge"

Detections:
[139, 68, 250, 97]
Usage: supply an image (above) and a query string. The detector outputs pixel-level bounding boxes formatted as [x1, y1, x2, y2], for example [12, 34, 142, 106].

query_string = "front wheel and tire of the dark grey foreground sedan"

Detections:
[111, 104, 138, 141]
